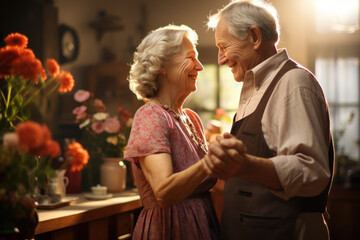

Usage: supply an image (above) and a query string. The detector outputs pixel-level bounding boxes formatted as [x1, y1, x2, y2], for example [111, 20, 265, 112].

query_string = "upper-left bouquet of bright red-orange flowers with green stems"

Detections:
[0, 33, 74, 135]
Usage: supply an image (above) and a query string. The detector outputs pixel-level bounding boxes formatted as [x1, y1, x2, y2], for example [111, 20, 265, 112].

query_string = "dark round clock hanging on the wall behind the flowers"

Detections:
[59, 24, 79, 64]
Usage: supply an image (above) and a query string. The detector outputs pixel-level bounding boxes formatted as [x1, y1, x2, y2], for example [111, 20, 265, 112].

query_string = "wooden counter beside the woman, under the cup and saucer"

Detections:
[35, 189, 142, 240]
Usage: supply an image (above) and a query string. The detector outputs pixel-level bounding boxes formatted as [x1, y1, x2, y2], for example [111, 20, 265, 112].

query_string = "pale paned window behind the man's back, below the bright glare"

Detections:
[315, 58, 359, 159]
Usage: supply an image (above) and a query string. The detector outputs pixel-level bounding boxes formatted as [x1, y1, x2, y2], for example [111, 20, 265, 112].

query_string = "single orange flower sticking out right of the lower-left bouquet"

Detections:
[64, 142, 89, 172]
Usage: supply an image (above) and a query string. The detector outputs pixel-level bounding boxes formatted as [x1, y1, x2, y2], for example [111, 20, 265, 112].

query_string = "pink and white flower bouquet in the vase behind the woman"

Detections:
[73, 89, 132, 190]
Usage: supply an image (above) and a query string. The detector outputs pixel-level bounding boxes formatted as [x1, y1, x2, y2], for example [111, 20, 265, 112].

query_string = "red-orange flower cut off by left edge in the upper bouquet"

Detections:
[0, 46, 22, 78]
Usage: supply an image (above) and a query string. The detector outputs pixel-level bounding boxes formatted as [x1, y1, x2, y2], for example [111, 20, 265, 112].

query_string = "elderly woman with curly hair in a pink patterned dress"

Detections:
[125, 25, 219, 239]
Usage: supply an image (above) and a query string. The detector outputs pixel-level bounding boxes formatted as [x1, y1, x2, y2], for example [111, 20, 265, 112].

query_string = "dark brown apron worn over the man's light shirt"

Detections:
[221, 61, 334, 240]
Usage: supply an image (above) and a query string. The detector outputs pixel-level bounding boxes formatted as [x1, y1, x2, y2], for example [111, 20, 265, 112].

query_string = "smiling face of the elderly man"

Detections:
[215, 18, 256, 82]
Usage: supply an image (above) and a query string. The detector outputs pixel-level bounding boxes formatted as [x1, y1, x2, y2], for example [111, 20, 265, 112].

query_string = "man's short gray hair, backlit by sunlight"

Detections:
[207, 0, 280, 44]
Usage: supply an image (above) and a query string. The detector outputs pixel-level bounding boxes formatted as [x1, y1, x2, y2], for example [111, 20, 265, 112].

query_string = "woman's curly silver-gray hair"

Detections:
[128, 25, 198, 100]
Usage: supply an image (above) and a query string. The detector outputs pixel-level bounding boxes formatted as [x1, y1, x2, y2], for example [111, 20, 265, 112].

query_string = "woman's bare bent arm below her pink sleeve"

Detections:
[139, 153, 207, 208]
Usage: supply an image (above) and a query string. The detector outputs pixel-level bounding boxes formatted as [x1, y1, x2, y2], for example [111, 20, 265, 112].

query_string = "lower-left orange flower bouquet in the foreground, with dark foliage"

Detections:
[0, 121, 89, 238]
